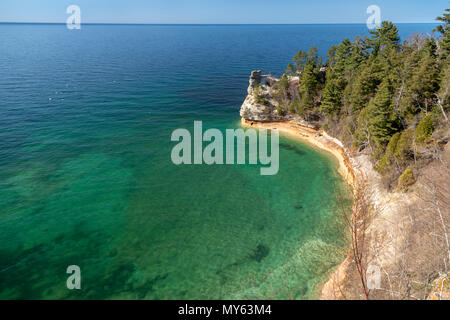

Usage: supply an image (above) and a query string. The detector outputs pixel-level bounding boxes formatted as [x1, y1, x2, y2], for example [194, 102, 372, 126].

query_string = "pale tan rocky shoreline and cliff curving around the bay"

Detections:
[240, 71, 428, 300]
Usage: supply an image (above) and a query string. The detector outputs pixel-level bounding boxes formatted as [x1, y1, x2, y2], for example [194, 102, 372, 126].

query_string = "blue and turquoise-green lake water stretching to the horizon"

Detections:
[0, 24, 433, 299]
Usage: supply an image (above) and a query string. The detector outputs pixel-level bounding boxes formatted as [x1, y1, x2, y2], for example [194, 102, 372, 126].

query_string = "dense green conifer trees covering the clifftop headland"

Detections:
[278, 4, 450, 175]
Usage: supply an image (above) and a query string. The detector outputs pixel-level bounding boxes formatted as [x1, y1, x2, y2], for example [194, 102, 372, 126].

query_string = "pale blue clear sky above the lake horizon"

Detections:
[0, 0, 450, 24]
